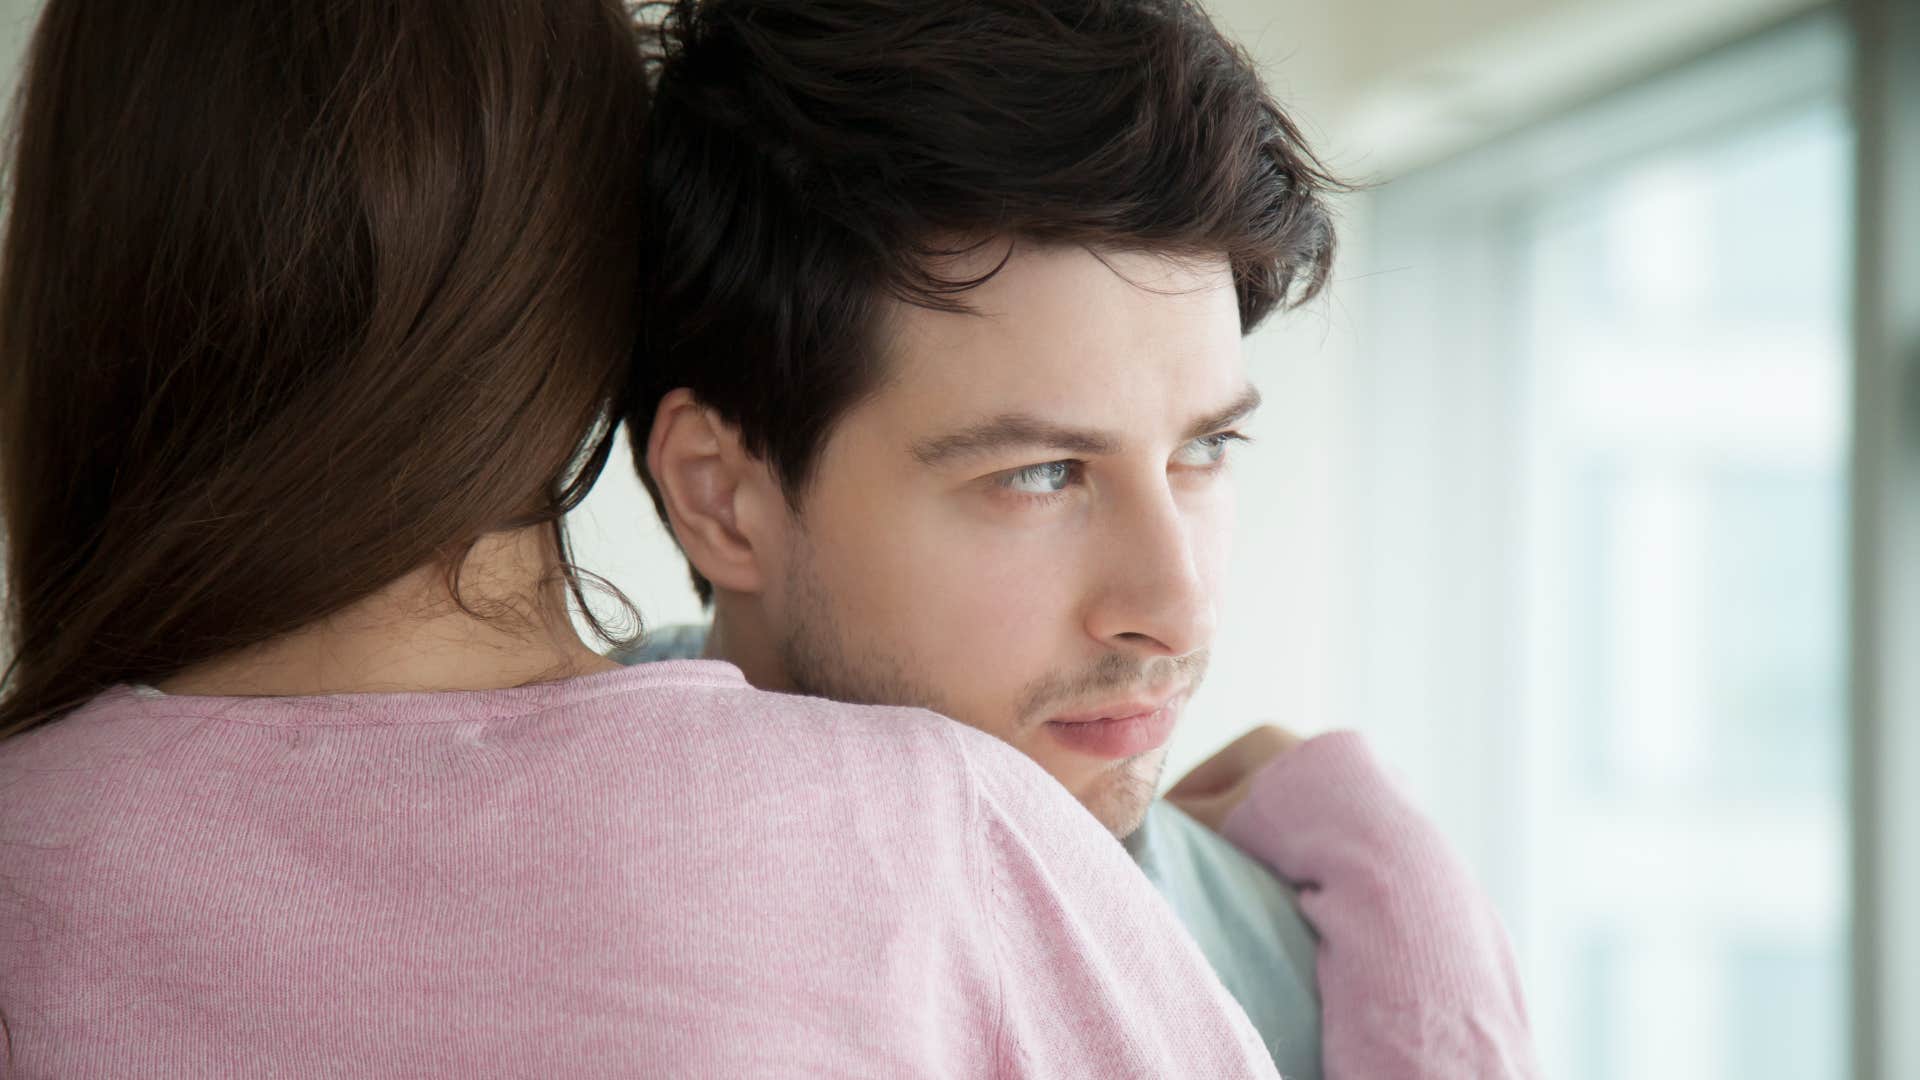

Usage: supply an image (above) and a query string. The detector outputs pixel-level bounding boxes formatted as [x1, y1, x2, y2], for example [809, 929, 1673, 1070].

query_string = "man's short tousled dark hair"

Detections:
[626, 0, 1342, 600]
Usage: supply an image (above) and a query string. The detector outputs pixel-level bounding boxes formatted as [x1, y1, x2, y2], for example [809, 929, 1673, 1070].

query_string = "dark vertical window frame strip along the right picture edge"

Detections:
[1847, 0, 1920, 1080]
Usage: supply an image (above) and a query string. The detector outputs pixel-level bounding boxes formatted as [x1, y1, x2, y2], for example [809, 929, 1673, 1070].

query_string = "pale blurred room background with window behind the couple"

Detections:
[6, 0, 1920, 1080]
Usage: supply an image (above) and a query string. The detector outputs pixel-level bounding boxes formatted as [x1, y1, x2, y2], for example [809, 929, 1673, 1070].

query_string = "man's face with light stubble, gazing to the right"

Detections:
[760, 246, 1254, 836]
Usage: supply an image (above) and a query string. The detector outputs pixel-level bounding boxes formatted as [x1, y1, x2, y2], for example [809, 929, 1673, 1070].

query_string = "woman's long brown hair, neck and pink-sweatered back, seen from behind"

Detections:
[0, 0, 1271, 1076]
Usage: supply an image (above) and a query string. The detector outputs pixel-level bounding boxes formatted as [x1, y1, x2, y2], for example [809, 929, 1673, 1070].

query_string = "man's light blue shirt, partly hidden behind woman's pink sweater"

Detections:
[614, 626, 1321, 1080]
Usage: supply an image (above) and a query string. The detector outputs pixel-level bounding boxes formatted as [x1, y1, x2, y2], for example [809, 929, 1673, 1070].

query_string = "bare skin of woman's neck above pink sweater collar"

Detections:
[157, 527, 618, 698]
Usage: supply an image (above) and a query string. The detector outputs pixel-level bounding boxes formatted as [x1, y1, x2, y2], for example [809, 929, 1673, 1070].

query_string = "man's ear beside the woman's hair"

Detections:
[647, 388, 785, 592]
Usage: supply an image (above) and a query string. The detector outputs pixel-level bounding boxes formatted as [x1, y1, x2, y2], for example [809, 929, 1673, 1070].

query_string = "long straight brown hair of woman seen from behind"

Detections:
[0, 0, 647, 738]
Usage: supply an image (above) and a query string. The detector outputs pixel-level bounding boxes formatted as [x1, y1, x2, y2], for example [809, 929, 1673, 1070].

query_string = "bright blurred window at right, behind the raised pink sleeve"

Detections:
[1352, 19, 1853, 1080]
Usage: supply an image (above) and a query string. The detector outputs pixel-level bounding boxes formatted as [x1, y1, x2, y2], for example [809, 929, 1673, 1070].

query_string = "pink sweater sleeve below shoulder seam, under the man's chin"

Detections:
[954, 724, 1277, 1080]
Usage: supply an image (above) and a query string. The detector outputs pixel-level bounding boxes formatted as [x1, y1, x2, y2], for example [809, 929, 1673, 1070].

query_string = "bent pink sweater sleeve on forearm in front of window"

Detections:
[1223, 732, 1540, 1080]
